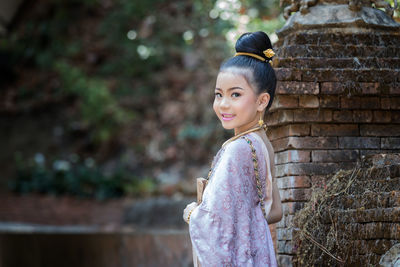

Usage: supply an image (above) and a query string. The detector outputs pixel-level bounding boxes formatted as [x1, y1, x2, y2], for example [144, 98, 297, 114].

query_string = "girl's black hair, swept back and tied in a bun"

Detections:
[219, 31, 276, 111]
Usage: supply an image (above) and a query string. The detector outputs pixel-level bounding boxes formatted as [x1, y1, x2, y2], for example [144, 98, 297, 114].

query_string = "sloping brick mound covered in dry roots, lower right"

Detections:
[292, 153, 400, 266]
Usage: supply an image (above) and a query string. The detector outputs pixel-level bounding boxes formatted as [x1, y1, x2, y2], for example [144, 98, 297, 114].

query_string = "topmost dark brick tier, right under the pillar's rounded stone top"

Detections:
[276, 33, 400, 47]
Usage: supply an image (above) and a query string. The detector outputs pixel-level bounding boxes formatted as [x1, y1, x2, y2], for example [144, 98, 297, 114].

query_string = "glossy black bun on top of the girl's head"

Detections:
[235, 31, 272, 60]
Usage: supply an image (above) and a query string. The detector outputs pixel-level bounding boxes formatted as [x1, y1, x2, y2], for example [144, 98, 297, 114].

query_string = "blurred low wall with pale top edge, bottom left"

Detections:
[0, 225, 193, 267]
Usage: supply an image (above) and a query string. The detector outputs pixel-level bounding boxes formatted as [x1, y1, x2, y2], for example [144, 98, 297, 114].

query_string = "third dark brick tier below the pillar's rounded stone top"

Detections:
[274, 57, 400, 71]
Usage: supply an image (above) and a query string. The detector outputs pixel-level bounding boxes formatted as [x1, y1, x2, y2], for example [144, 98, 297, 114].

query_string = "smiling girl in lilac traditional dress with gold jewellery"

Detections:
[183, 32, 282, 267]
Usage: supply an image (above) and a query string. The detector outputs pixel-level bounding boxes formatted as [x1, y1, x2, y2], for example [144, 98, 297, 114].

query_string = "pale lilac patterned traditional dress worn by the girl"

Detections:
[189, 132, 277, 267]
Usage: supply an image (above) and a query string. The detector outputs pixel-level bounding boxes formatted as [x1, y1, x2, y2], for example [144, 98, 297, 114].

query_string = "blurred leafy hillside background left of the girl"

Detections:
[0, 0, 284, 198]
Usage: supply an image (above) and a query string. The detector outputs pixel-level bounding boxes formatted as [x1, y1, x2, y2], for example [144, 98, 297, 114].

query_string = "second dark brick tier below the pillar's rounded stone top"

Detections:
[277, 44, 400, 58]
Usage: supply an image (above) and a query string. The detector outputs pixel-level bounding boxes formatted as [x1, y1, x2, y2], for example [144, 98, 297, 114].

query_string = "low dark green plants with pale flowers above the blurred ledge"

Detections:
[9, 154, 156, 200]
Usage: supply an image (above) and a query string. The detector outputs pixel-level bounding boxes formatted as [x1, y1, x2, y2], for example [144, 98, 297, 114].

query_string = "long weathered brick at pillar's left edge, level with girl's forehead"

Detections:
[276, 81, 319, 95]
